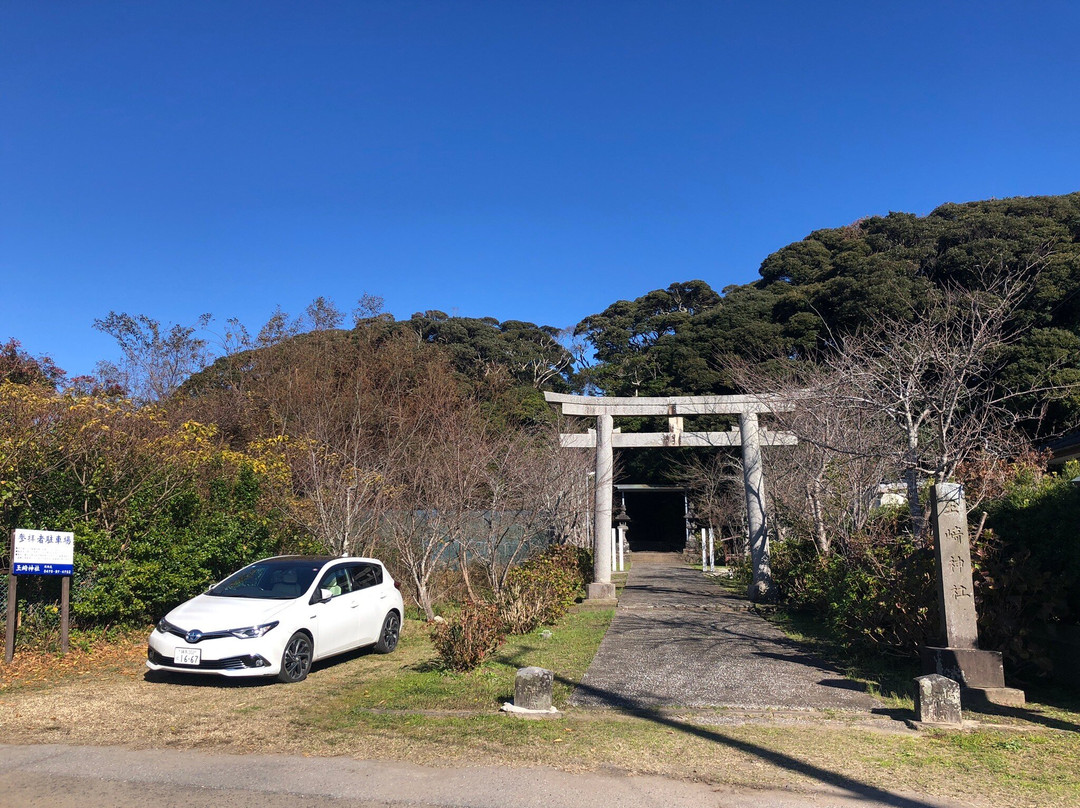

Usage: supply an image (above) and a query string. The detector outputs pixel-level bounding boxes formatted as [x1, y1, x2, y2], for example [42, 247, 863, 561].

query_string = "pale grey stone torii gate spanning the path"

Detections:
[544, 393, 797, 602]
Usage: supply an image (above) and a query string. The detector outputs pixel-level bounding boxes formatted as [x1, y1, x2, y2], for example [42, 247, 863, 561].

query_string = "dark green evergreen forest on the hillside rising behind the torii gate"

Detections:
[576, 193, 1080, 428]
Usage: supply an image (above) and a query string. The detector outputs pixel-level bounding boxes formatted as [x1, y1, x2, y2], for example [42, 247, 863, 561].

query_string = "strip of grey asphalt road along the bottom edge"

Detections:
[0, 744, 956, 808]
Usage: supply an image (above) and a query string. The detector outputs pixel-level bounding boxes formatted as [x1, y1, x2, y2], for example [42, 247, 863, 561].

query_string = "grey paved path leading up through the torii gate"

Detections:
[571, 553, 881, 710]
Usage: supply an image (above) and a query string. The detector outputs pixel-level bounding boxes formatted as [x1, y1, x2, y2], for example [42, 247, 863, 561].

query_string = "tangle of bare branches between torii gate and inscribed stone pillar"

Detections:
[729, 252, 1069, 553]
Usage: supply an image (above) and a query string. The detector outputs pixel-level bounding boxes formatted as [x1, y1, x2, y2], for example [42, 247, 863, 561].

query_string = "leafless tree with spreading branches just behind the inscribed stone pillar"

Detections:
[826, 258, 1065, 534]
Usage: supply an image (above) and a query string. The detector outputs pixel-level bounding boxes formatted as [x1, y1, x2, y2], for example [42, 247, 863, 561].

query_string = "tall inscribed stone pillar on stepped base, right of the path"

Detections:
[922, 483, 1024, 706]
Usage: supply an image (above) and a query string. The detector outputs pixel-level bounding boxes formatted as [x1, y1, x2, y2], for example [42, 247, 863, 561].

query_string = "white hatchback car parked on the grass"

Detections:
[146, 555, 405, 682]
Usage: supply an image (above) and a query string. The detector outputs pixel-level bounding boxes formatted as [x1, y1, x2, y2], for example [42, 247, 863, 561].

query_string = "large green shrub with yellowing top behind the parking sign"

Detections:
[0, 382, 299, 636]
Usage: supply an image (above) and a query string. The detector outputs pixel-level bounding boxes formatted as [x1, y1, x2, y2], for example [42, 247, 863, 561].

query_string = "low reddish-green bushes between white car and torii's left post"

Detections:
[431, 544, 592, 671]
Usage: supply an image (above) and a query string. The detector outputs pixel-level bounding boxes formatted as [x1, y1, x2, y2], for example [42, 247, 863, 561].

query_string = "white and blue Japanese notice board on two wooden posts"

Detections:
[4, 529, 75, 663]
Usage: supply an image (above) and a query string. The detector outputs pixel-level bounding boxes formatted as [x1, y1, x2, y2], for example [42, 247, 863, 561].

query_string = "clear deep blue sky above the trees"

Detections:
[0, 0, 1080, 374]
